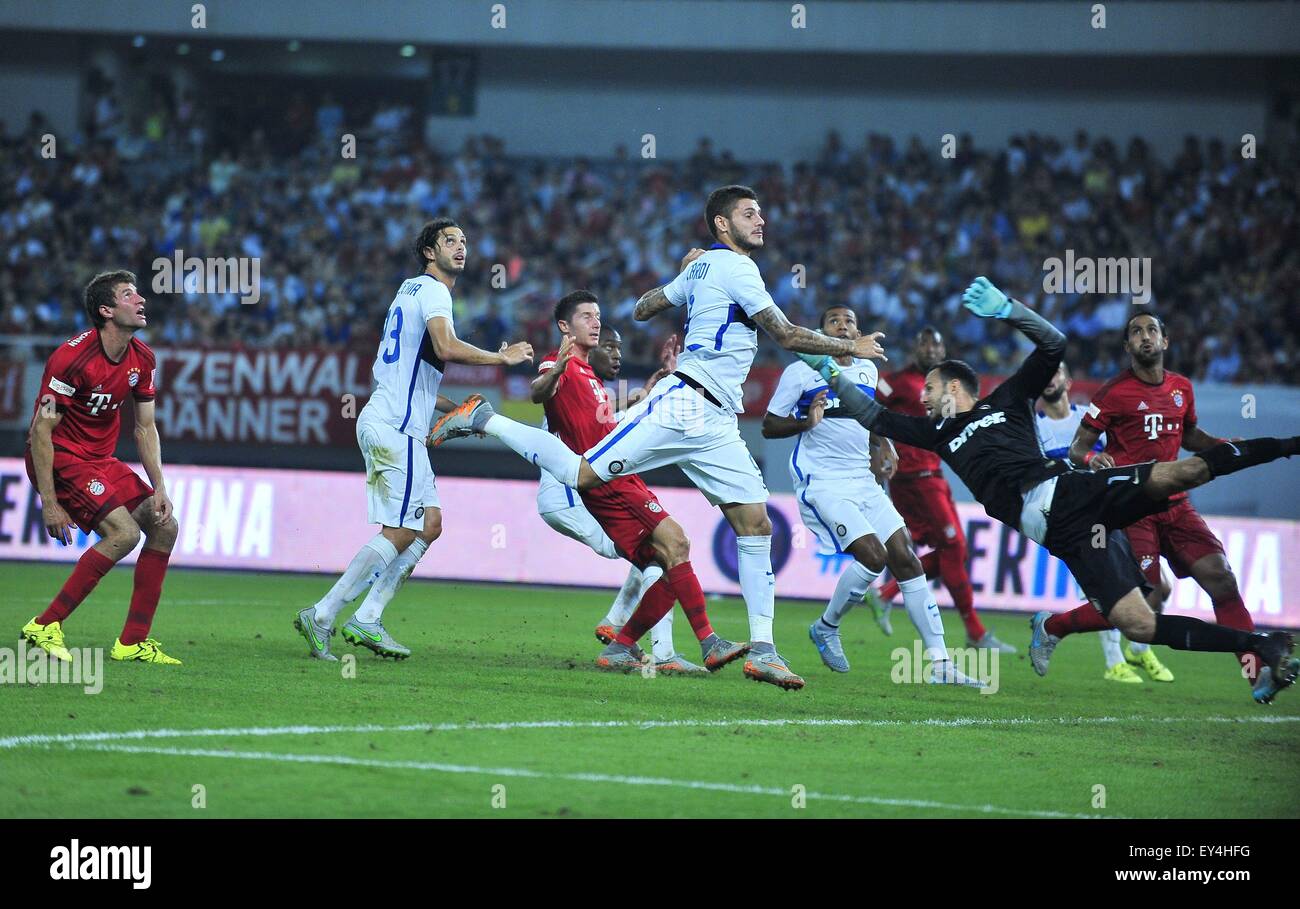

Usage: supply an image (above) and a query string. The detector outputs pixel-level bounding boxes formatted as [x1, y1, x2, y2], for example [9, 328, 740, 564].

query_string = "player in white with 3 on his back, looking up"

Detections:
[294, 217, 533, 659]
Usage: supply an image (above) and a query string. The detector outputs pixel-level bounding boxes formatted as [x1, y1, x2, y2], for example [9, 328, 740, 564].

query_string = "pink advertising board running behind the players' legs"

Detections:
[0, 458, 1300, 628]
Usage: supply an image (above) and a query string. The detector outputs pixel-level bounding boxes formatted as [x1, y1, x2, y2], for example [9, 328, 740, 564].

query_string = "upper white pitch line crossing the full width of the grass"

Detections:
[0, 714, 1300, 749]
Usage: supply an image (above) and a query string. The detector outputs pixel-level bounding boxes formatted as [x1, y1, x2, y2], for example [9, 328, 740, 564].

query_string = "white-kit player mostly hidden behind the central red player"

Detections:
[533, 325, 709, 675]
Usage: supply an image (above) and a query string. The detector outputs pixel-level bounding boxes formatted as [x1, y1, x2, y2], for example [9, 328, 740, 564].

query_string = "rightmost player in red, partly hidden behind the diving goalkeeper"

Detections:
[1048, 312, 1268, 684]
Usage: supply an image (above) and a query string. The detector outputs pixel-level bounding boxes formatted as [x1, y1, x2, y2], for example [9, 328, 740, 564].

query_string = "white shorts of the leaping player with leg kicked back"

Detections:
[586, 376, 767, 505]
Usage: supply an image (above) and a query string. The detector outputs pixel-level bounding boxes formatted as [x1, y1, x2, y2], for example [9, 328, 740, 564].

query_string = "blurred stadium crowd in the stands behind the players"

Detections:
[0, 88, 1300, 385]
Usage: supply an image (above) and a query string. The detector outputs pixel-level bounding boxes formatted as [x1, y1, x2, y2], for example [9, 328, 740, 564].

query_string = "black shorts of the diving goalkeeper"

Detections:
[1044, 462, 1171, 615]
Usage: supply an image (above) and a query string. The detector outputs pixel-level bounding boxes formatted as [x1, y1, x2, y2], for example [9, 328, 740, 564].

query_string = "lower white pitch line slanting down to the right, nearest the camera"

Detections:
[72, 744, 1118, 821]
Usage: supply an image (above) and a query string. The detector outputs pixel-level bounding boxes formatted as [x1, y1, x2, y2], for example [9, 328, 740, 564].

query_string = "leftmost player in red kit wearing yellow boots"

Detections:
[22, 270, 181, 665]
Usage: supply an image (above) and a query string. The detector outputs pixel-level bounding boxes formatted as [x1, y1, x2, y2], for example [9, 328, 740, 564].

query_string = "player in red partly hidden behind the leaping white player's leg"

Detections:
[532, 290, 749, 671]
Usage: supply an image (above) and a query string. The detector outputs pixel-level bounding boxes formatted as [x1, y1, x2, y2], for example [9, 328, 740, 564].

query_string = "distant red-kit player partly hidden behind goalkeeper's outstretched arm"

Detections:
[867, 325, 1015, 654]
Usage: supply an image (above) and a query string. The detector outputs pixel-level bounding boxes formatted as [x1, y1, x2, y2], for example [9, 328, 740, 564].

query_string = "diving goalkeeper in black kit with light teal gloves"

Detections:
[800, 277, 1300, 704]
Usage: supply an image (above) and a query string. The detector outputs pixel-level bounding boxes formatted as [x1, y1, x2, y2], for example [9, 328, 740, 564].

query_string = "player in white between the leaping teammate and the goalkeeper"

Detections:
[763, 306, 982, 687]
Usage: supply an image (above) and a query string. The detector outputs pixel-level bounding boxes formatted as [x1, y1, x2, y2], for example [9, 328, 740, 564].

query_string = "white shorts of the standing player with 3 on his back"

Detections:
[356, 419, 441, 531]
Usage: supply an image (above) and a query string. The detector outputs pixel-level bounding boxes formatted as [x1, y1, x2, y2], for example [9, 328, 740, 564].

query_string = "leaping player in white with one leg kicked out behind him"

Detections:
[429, 186, 884, 689]
